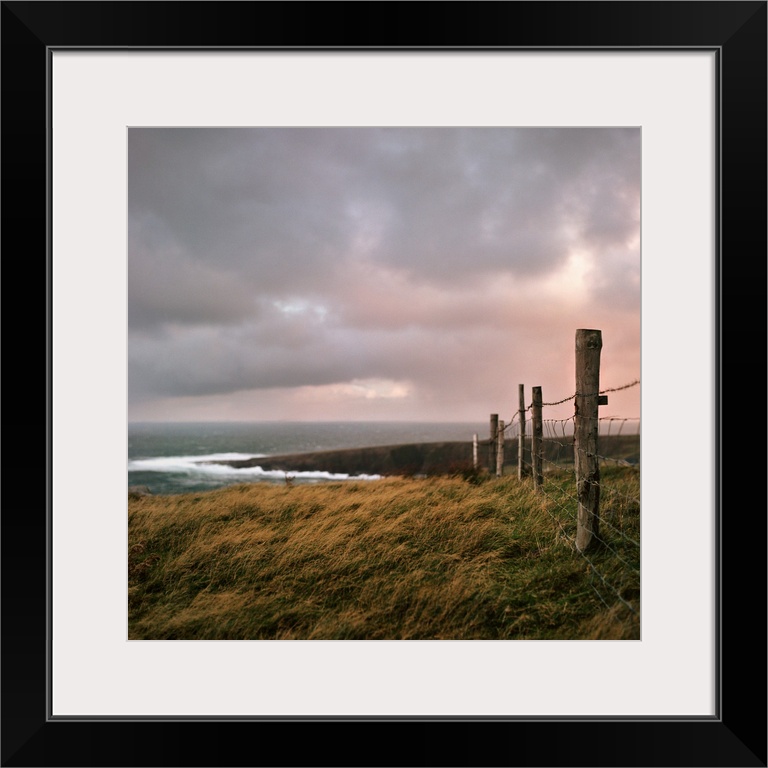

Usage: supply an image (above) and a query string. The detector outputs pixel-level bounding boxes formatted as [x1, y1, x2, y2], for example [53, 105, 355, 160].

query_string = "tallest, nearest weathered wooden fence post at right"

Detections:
[573, 328, 603, 552]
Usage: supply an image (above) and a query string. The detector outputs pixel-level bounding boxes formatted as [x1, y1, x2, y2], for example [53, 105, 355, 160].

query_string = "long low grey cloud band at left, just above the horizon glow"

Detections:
[129, 318, 498, 397]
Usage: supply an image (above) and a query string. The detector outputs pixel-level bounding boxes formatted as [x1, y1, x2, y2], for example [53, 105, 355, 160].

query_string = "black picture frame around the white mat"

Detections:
[0, 0, 768, 767]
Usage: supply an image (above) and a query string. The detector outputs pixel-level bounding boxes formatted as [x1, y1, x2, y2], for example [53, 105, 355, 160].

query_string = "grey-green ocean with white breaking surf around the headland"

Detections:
[128, 421, 488, 494]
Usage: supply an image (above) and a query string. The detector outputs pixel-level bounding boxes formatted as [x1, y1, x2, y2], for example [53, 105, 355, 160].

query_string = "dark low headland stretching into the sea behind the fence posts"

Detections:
[210, 435, 640, 475]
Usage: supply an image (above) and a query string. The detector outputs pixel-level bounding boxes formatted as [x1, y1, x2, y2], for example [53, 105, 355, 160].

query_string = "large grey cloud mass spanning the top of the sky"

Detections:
[129, 128, 639, 300]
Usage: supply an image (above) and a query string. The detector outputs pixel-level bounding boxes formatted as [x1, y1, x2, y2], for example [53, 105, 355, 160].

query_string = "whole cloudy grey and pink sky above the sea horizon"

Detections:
[128, 127, 641, 422]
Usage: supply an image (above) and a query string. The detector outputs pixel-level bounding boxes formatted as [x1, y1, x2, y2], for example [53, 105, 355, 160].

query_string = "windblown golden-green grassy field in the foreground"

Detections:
[128, 467, 640, 640]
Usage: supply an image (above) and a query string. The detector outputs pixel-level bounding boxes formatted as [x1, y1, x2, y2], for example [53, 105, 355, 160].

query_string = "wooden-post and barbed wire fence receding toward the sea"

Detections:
[476, 330, 640, 616]
